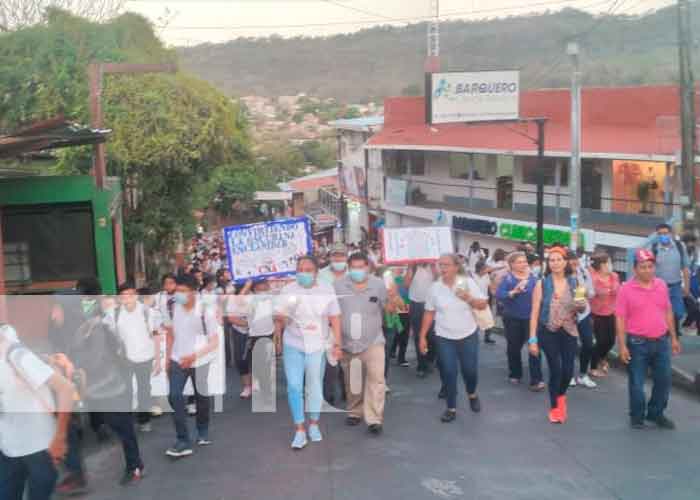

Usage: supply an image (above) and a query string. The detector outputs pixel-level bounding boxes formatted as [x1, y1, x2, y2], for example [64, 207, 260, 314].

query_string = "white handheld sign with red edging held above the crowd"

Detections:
[382, 226, 454, 264]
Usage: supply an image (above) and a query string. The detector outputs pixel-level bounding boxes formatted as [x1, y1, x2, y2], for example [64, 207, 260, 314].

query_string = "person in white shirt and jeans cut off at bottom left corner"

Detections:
[0, 325, 73, 500]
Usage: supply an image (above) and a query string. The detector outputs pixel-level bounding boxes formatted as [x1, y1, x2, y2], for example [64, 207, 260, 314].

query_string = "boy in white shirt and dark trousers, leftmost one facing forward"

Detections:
[110, 283, 161, 432]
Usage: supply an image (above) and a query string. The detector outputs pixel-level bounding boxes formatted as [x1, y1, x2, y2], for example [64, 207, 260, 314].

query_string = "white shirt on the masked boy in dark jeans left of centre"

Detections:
[170, 300, 219, 366]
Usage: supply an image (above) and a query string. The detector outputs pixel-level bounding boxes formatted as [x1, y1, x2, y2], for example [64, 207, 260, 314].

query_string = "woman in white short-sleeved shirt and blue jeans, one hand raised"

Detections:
[420, 254, 488, 422]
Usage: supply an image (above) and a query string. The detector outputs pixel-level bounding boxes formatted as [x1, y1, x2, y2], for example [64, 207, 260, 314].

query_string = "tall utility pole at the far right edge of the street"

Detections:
[678, 0, 697, 230]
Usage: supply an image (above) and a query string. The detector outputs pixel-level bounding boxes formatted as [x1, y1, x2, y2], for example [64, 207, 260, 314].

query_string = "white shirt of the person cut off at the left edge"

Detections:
[0, 326, 56, 458]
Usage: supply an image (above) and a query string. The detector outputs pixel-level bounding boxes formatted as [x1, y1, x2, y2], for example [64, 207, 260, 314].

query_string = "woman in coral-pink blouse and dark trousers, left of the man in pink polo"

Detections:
[590, 252, 620, 377]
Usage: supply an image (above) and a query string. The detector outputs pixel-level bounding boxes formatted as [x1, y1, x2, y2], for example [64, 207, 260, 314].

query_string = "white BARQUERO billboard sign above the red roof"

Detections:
[430, 71, 520, 123]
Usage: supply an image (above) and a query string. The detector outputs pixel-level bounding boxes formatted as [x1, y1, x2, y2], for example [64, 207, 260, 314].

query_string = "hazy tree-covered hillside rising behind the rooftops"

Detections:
[178, 7, 700, 102]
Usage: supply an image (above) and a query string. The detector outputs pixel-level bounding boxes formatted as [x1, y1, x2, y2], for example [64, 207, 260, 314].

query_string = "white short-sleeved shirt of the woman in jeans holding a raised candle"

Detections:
[425, 279, 486, 340]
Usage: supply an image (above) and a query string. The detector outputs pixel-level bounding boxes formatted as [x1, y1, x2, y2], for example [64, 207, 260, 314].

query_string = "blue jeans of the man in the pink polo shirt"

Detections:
[627, 335, 672, 422]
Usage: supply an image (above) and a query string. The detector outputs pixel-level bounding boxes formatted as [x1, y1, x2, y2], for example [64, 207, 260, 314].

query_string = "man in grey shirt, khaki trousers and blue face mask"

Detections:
[335, 252, 396, 435]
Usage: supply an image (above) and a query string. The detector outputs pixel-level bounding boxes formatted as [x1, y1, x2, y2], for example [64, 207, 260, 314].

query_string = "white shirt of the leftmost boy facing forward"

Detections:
[116, 303, 160, 363]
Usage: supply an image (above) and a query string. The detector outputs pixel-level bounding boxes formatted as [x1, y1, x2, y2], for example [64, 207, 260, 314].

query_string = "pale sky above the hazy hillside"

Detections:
[126, 0, 675, 45]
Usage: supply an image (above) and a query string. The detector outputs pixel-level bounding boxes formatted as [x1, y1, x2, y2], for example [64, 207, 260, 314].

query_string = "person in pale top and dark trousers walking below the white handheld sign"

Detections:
[404, 263, 437, 378]
